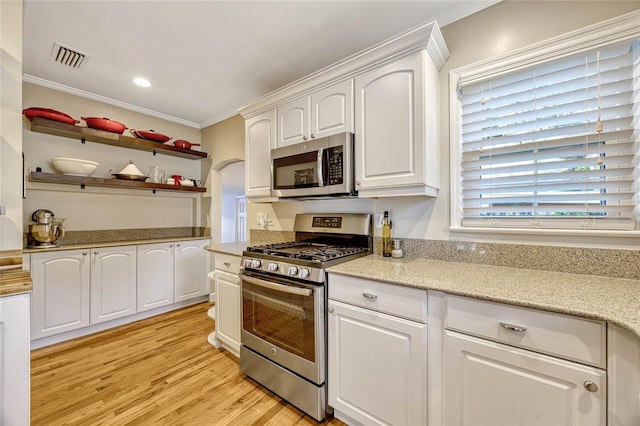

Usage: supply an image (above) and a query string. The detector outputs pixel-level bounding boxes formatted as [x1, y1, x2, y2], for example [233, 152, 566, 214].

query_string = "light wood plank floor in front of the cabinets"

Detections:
[31, 303, 344, 426]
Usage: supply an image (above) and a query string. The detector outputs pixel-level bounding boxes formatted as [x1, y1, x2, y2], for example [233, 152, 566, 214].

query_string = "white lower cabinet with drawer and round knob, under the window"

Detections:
[442, 296, 607, 426]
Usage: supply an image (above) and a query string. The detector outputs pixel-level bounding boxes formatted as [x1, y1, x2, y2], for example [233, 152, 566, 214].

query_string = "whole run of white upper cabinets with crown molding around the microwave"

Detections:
[240, 21, 449, 201]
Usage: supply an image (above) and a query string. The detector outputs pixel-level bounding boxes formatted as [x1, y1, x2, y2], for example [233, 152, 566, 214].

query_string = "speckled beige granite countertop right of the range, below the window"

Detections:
[327, 255, 640, 336]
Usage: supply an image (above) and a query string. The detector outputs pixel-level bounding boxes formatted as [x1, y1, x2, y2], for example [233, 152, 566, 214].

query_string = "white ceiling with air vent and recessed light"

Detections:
[23, 0, 497, 128]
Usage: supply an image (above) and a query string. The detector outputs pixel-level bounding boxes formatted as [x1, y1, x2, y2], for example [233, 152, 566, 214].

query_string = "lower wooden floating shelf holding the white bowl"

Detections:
[29, 172, 207, 192]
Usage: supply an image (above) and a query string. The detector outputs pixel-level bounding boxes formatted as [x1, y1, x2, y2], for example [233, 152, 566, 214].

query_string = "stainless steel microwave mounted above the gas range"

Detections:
[271, 132, 355, 198]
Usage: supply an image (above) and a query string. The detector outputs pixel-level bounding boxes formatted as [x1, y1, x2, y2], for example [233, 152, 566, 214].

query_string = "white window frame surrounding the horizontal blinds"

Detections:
[449, 11, 640, 238]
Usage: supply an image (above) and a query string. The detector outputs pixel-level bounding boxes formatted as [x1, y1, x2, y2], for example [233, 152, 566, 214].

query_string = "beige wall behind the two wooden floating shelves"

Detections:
[23, 83, 206, 231]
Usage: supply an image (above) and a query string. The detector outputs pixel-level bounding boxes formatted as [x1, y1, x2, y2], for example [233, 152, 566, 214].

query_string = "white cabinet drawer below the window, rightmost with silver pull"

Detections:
[445, 296, 606, 368]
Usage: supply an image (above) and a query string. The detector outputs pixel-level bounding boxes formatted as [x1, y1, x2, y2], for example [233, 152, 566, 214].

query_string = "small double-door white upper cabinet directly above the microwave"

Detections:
[277, 80, 353, 147]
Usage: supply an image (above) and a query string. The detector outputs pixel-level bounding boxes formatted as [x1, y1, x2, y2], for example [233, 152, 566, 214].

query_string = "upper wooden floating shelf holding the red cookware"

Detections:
[31, 117, 207, 160]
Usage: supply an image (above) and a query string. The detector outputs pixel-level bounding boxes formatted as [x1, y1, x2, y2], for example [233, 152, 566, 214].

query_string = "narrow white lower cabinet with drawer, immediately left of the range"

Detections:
[214, 253, 242, 356]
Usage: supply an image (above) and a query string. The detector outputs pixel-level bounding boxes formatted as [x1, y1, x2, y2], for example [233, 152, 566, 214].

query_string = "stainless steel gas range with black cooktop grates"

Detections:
[240, 213, 373, 421]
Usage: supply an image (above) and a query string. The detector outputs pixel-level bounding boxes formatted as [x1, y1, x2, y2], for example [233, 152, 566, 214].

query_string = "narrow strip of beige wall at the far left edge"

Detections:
[0, 1, 22, 251]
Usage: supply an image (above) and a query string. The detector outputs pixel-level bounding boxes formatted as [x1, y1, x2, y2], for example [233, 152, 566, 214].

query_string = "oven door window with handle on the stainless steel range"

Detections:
[242, 274, 316, 362]
